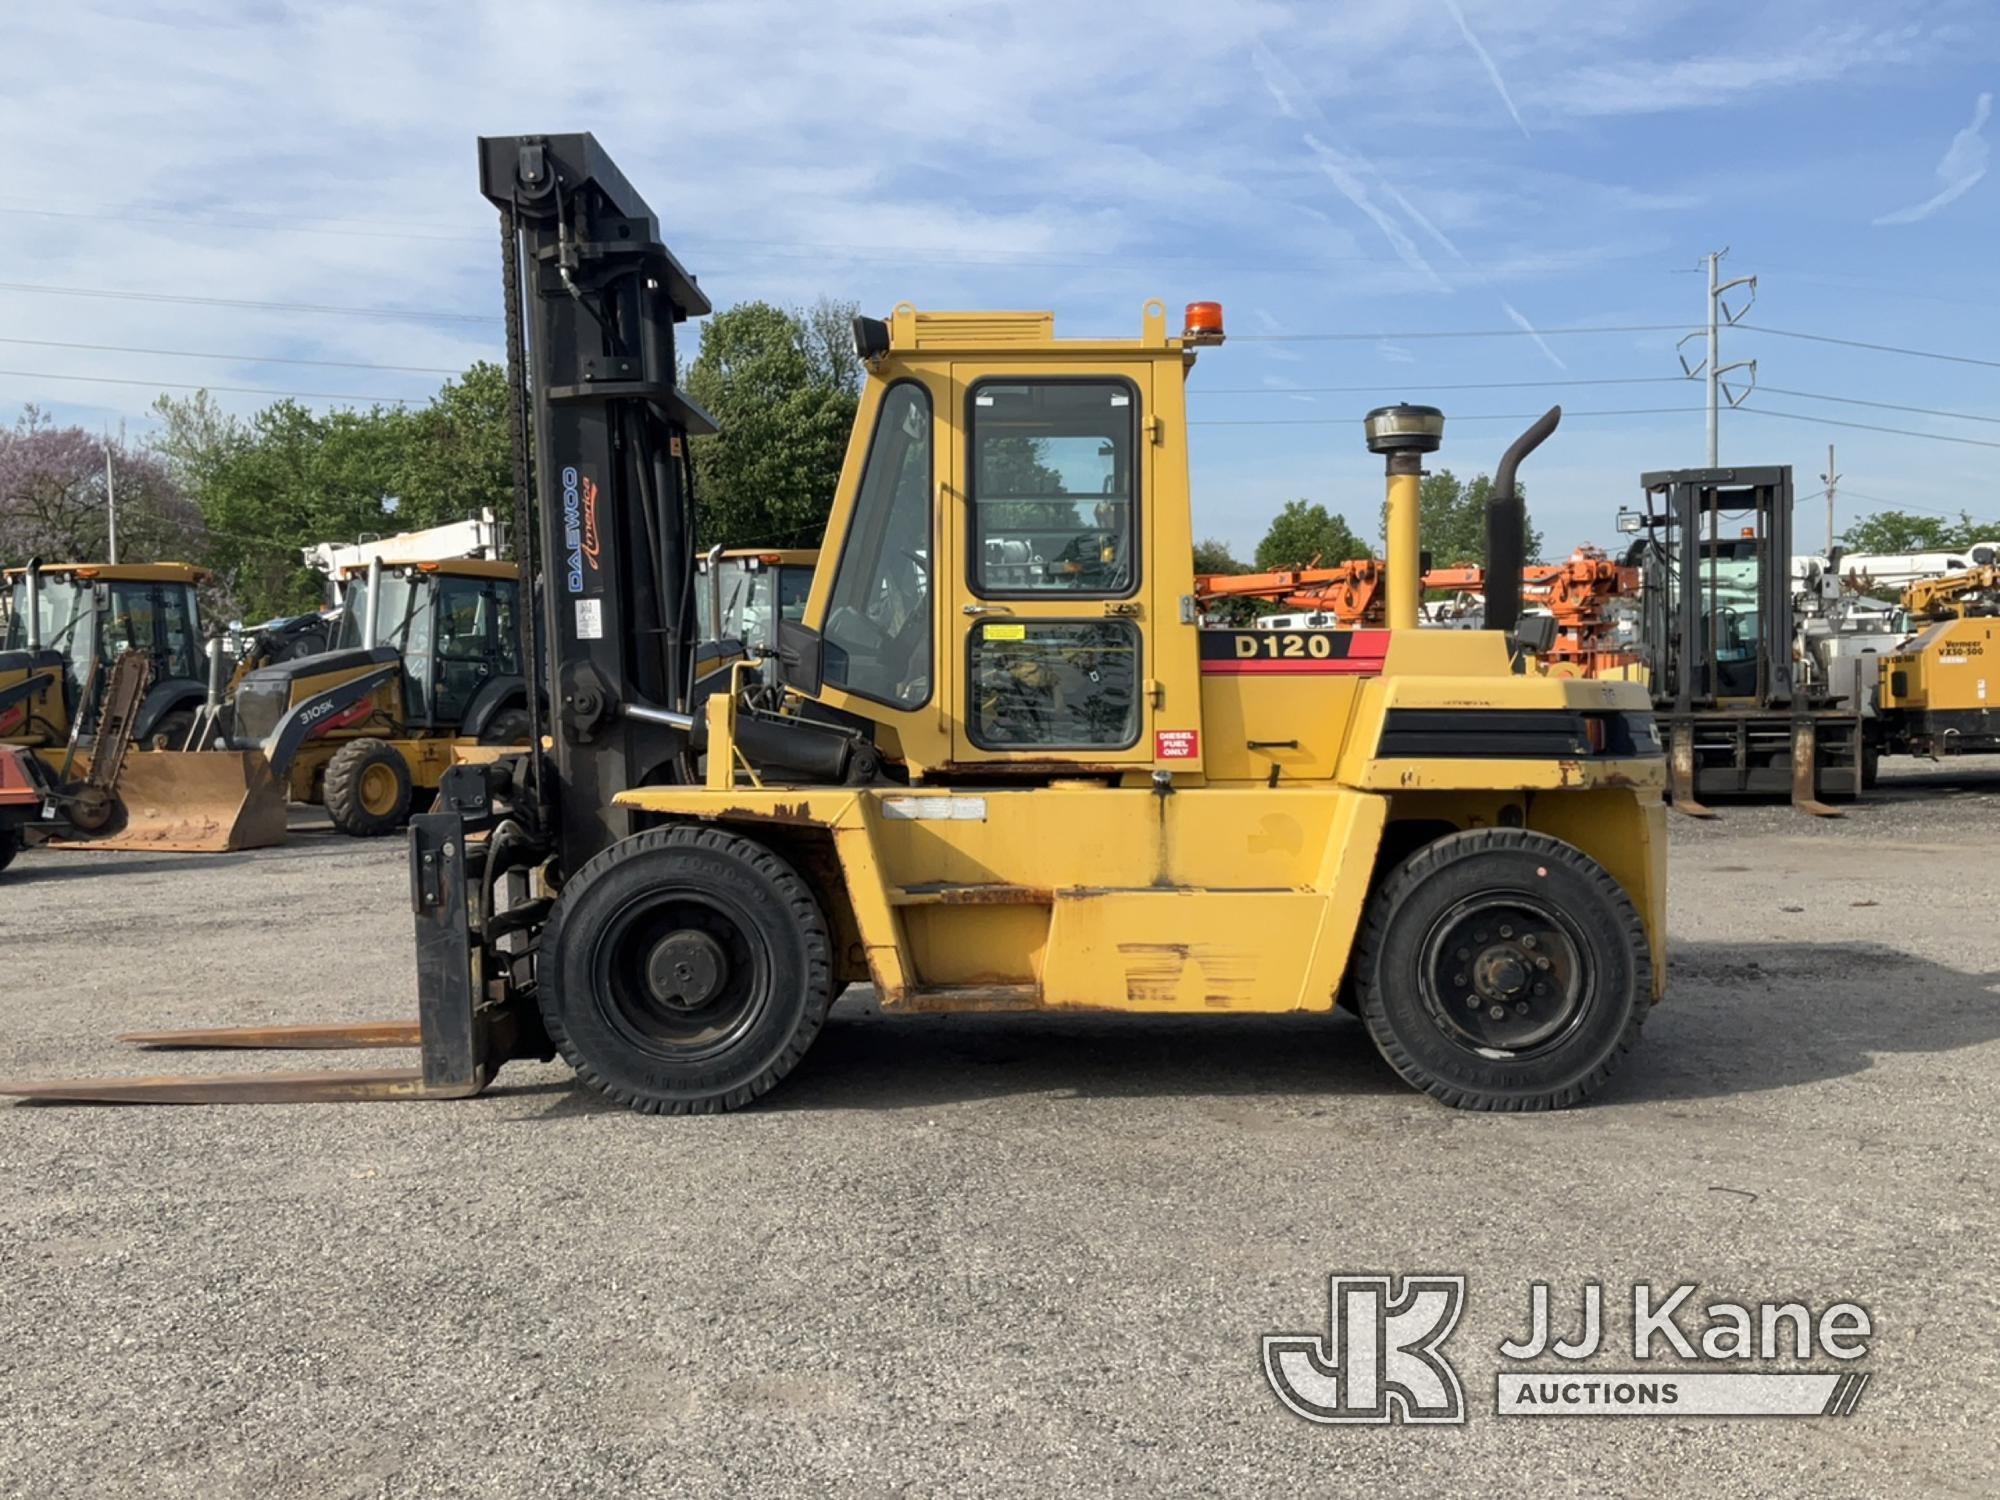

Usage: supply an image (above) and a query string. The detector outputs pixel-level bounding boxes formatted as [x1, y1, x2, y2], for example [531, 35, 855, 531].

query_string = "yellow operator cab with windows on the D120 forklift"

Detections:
[790, 302, 1200, 780]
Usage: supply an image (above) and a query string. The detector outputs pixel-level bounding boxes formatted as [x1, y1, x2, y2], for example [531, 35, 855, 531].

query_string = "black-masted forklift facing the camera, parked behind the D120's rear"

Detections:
[1620, 468, 1866, 818]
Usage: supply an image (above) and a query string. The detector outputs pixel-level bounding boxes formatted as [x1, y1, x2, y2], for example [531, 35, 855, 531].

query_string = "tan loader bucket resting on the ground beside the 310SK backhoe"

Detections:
[78, 750, 286, 854]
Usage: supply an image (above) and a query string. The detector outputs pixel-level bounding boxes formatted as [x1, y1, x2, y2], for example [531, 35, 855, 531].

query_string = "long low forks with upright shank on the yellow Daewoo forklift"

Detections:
[0, 812, 514, 1104]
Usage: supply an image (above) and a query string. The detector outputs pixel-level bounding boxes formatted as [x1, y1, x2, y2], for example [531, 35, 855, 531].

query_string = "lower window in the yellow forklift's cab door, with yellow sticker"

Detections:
[966, 620, 1140, 750]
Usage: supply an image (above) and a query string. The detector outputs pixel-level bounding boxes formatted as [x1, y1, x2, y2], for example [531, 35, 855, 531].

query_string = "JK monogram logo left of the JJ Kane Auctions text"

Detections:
[1264, 1276, 1466, 1422]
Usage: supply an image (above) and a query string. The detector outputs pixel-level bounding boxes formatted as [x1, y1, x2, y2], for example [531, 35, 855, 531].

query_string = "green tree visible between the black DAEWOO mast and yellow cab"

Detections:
[686, 302, 860, 546]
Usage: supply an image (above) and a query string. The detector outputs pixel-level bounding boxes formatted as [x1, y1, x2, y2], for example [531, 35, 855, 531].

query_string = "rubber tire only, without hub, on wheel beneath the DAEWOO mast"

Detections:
[536, 824, 834, 1114]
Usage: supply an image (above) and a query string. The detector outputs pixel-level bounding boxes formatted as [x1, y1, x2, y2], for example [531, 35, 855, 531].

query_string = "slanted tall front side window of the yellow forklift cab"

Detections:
[820, 380, 932, 708]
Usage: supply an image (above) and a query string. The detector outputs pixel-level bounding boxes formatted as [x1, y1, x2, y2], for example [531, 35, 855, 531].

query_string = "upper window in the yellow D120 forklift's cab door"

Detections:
[968, 380, 1138, 598]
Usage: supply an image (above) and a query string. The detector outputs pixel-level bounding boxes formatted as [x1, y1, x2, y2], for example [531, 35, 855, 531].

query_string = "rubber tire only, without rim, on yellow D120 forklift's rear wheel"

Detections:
[1354, 828, 1652, 1110]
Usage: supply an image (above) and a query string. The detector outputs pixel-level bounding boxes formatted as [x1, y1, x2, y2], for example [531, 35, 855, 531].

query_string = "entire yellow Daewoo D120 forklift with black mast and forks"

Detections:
[8, 136, 1666, 1112]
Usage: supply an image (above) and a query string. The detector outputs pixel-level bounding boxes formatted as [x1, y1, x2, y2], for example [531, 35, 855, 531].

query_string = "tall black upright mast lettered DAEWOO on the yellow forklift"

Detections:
[480, 134, 716, 870]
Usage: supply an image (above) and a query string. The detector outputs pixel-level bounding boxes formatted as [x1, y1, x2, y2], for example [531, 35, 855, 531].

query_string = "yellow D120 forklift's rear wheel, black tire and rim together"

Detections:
[1356, 828, 1652, 1110]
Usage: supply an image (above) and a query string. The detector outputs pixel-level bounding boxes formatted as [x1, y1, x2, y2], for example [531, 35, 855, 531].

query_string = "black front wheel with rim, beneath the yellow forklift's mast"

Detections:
[536, 824, 834, 1114]
